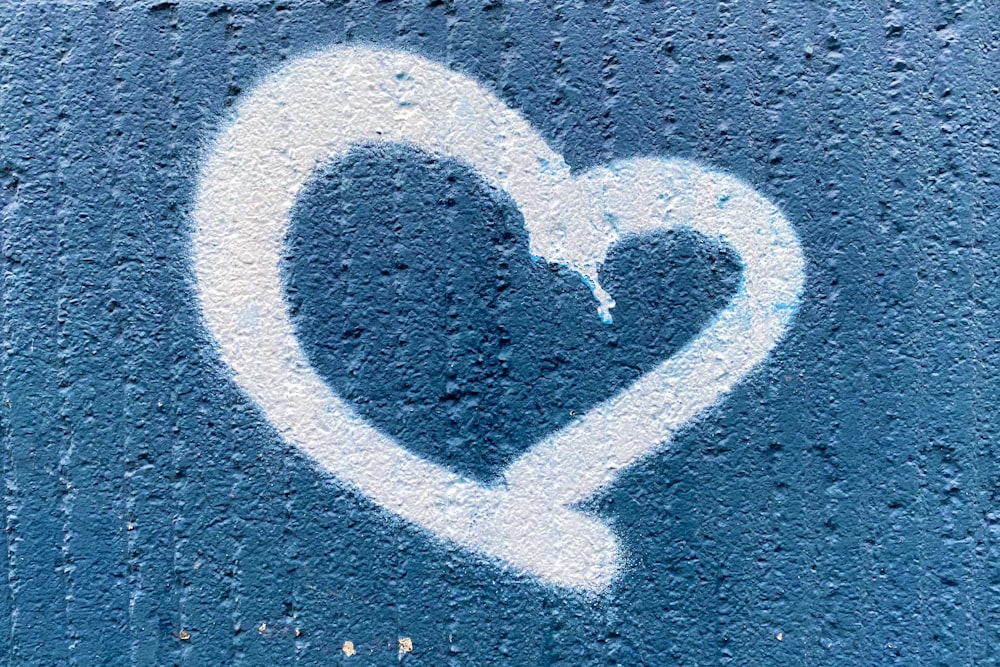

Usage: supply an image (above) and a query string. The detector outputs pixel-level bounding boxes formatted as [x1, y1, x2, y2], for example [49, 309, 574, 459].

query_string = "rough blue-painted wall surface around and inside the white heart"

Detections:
[0, 0, 1000, 667]
